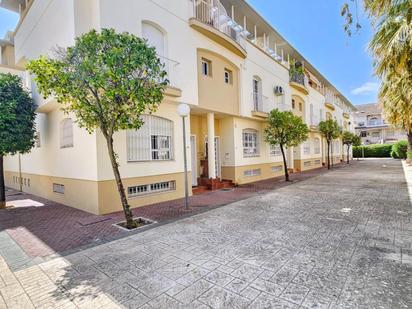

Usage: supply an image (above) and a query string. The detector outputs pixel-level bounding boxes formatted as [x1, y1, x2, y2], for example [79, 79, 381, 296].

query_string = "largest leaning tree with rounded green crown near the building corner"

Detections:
[28, 29, 168, 228]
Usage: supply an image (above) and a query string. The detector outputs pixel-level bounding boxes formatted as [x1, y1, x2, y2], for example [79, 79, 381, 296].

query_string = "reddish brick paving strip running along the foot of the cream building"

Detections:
[0, 162, 346, 260]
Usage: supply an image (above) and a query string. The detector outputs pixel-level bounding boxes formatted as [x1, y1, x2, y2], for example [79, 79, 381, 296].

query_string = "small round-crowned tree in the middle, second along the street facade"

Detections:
[264, 109, 309, 181]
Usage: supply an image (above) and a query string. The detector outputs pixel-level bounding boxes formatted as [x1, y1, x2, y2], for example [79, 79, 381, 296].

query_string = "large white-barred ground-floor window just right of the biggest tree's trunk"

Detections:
[127, 115, 173, 162]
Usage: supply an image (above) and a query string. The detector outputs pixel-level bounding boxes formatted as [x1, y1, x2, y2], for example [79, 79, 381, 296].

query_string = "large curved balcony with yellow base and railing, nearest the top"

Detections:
[189, 0, 247, 59]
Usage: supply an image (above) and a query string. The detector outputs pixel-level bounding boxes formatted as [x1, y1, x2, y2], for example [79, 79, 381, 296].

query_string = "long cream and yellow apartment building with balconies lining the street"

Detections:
[0, 0, 355, 214]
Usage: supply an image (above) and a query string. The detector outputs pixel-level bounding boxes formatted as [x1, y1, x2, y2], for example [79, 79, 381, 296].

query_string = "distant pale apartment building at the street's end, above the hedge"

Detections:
[355, 103, 408, 145]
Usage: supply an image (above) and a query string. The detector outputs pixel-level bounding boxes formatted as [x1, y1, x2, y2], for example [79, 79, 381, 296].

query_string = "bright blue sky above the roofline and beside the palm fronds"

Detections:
[0, 0, 378, 104]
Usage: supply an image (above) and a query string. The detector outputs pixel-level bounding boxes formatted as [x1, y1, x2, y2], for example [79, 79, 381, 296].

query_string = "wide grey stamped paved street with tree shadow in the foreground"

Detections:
[0, 160, 412, 309]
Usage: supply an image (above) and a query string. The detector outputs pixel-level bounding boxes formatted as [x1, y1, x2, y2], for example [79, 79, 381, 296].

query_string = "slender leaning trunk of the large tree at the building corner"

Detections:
[105, 135, 137, 229]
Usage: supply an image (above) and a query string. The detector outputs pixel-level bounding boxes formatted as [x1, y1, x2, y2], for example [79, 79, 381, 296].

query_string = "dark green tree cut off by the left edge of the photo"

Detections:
[0, 73, 36, 208]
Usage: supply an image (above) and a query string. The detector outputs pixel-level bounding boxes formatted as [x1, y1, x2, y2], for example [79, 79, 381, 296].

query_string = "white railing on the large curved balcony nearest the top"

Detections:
[193, 0, 245, 48]
